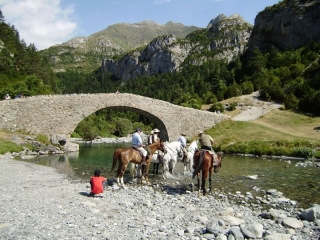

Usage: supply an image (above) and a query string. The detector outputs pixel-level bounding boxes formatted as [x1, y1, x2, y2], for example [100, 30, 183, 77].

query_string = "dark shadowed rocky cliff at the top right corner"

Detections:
[248, 0, 320, 50]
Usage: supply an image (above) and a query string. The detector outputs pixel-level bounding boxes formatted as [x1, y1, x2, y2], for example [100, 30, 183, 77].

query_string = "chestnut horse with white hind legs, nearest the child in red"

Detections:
[110, 141, 165, 186]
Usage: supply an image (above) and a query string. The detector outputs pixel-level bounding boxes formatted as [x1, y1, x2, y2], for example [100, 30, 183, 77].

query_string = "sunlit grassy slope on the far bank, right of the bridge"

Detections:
[206, 109, 320, 158]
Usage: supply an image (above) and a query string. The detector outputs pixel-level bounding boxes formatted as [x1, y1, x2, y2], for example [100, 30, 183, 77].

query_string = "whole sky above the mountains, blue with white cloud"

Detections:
[0, 0, 279, 50]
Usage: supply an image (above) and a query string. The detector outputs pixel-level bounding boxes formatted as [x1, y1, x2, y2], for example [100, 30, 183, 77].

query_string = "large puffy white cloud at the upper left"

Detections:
[0, 0, 77, 50]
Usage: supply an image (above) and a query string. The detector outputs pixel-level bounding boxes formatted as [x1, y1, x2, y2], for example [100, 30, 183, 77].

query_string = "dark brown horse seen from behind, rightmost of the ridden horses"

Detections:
[192, 150, 223, 197]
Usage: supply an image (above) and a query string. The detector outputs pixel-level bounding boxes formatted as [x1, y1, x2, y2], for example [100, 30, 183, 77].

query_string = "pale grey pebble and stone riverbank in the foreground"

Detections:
[0, 154, 319, 239]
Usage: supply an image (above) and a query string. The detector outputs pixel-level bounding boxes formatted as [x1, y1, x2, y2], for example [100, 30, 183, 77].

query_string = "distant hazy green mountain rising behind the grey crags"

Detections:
[41, 21, 199, 72]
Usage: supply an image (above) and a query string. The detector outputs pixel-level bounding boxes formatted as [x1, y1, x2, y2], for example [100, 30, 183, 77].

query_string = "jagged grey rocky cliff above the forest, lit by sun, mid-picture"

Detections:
[101, 14, 252, 80]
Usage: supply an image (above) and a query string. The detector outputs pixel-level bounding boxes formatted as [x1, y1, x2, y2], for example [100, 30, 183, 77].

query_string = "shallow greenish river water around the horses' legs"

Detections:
[18, 143, 320, 208]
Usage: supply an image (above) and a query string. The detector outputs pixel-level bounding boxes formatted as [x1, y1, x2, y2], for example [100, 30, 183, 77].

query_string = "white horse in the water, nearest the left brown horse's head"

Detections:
[163, 141, 182, 176]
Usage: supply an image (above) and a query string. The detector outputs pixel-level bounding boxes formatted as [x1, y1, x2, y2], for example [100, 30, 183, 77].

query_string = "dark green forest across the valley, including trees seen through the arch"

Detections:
[0, 10, 320, 139]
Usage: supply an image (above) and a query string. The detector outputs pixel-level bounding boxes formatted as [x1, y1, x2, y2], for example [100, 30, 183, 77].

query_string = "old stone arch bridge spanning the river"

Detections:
[0, 93, 228, 141]
